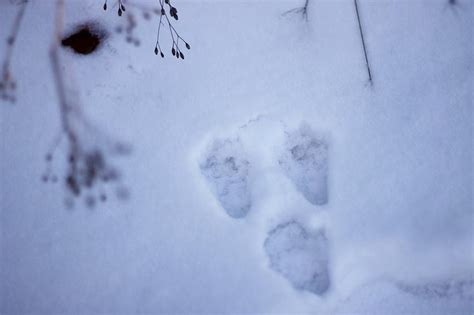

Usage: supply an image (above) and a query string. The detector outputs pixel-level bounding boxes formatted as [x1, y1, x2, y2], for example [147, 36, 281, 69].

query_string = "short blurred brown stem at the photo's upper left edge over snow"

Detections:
[0, 0, 28, 102]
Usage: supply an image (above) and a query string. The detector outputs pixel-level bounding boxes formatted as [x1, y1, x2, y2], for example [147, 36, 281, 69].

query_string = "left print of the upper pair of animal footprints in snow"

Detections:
[200, 139, 252, 218]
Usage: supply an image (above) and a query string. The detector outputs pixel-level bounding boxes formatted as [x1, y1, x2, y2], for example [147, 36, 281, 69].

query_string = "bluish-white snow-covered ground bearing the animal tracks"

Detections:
[0, 0, 474, 314]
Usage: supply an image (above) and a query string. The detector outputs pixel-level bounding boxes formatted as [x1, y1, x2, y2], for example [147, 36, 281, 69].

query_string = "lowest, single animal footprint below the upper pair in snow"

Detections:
[264, 221, 329, 295]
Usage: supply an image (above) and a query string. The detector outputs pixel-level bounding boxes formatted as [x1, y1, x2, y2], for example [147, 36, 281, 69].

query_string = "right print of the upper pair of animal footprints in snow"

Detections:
[279, 125, 328, 205]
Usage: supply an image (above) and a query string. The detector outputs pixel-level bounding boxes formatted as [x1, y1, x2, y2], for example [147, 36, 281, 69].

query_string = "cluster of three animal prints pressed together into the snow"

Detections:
[199, 116, 330, 295]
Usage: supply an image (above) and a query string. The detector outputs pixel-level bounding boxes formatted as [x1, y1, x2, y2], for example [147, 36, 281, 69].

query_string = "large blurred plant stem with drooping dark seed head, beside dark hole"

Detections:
[47, 0, 128, 207]
